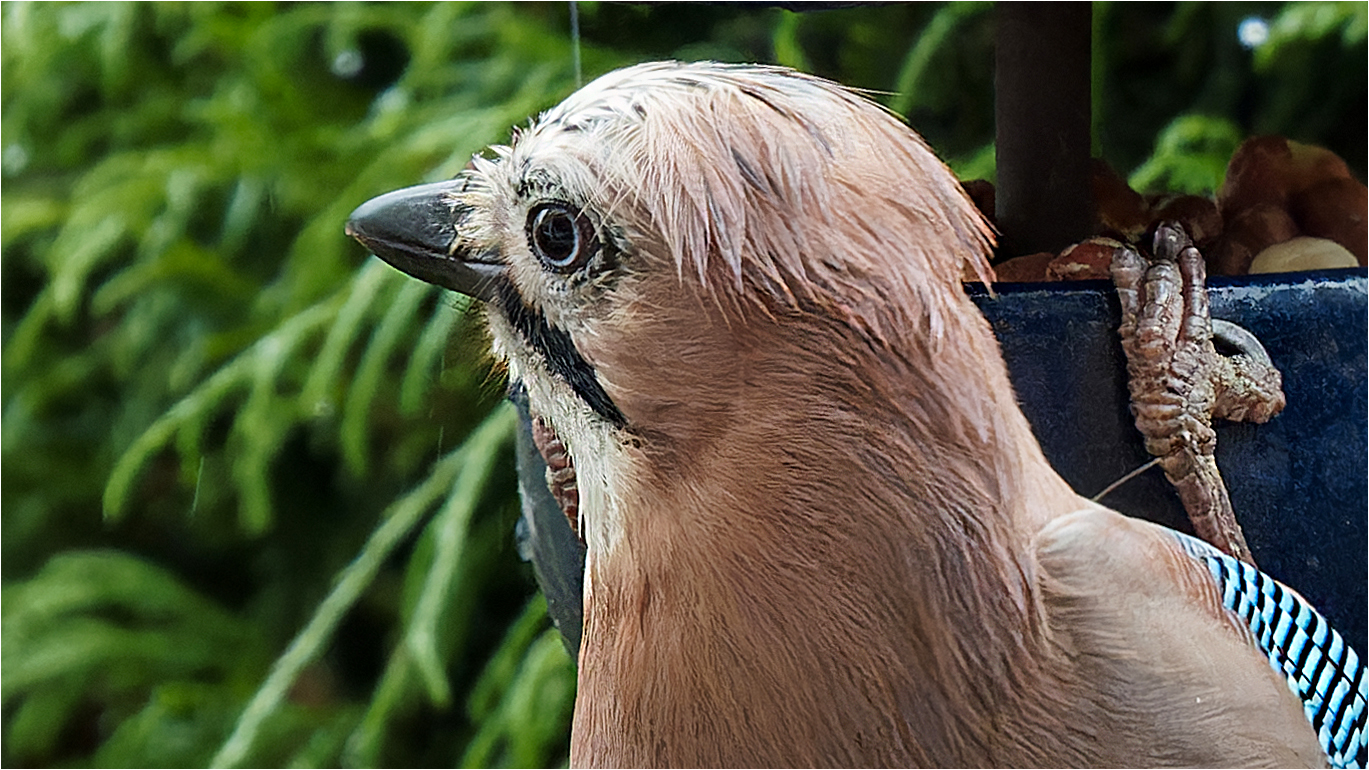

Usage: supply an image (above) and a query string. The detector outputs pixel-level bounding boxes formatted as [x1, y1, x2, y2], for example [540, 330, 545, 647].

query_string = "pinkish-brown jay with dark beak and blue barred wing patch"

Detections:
[346, 62, 1365, 767]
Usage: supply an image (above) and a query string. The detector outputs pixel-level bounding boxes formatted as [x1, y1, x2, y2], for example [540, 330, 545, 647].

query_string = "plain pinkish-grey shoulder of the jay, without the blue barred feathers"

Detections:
[1035, 507, 1327, 767]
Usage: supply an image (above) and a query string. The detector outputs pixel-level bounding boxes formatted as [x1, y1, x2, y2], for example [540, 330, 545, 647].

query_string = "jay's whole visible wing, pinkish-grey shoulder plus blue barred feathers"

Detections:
[1036, 507, 1366, 767]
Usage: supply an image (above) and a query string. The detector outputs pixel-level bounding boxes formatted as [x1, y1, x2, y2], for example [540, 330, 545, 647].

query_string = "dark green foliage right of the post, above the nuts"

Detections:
[1094, 3, 1369, 192]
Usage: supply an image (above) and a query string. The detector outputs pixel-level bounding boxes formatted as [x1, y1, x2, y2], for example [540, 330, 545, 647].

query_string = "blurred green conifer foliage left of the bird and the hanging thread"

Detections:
[3, 3, 594, 766]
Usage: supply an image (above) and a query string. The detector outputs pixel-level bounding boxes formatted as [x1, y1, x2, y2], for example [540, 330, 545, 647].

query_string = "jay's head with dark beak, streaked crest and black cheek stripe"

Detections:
[348, 63, 988, 554]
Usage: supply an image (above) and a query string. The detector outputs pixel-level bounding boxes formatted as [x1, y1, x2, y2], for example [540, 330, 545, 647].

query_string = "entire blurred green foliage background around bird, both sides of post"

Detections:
[0, 3, 1369, 767]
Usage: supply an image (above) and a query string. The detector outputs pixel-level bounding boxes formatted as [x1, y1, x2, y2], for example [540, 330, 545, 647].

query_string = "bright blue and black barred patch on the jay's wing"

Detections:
[1175, 532, 1369, 767]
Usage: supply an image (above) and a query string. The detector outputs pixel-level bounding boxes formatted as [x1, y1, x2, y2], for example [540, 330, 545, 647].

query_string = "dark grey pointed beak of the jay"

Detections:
[346, 179, 505, 300]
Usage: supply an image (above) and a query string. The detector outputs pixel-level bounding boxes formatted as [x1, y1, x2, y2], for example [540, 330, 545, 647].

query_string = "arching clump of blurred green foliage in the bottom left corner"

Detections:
[0, 551, 268, 765]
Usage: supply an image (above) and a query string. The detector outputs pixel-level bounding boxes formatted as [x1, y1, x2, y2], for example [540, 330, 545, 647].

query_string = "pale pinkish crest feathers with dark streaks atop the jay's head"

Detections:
[538, 62, 991, 338]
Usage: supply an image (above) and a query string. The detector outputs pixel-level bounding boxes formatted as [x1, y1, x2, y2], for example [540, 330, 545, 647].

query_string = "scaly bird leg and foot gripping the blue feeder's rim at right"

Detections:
[1112, 222, 1284, 564]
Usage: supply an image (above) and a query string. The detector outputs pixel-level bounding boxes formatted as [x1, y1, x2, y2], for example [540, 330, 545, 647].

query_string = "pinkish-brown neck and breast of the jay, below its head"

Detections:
[572, 291, 1080, 765]
